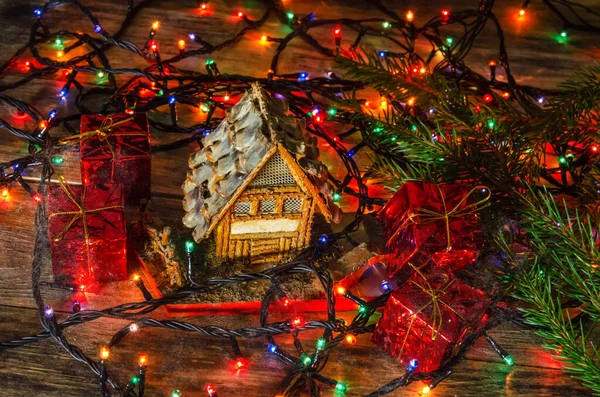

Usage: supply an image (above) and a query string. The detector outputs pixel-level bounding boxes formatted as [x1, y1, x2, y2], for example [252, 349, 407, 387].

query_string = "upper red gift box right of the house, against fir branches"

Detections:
[380, 182, 490, 274]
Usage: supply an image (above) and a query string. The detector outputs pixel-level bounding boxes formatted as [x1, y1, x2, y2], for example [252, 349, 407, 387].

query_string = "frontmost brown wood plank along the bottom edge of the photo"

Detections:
[0, 304, 590, 396]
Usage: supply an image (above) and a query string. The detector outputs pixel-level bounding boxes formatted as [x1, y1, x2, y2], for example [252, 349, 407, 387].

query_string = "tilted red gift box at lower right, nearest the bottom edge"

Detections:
[372, 266, 490, 372]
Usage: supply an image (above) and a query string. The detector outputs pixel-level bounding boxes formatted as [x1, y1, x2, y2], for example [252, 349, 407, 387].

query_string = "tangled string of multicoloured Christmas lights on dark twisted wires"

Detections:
[0, 0, 598, 397]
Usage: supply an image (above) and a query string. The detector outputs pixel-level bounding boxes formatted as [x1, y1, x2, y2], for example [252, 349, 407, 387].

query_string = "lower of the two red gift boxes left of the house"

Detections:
[48, 177, 127, 286]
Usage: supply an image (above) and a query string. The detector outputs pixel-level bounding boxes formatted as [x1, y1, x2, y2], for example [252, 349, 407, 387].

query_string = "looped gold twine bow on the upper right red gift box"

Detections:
[408, 185, 492, 251]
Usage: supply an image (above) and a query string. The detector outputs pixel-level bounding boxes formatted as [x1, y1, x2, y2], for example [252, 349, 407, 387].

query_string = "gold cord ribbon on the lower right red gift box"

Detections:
[400, 262, 464, 355]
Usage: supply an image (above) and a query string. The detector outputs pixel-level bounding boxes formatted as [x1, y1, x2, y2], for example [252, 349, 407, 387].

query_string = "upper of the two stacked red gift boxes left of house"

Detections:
[77, 113, 150, 204]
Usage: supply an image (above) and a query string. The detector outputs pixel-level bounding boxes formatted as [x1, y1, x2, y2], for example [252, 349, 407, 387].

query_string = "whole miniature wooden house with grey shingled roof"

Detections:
[183, 84, 341, 264]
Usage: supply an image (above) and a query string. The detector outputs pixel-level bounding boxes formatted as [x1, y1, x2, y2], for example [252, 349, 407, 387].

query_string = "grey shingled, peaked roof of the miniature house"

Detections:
[182, 83, 341, 241]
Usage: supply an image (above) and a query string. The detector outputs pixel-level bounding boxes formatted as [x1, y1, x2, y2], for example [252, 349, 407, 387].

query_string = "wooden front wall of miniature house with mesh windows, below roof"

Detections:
[209, 145, 329, 264]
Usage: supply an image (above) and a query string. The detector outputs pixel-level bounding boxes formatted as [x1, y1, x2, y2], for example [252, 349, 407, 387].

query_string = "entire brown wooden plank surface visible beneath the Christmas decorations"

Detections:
[0, 0, 599, 397]
